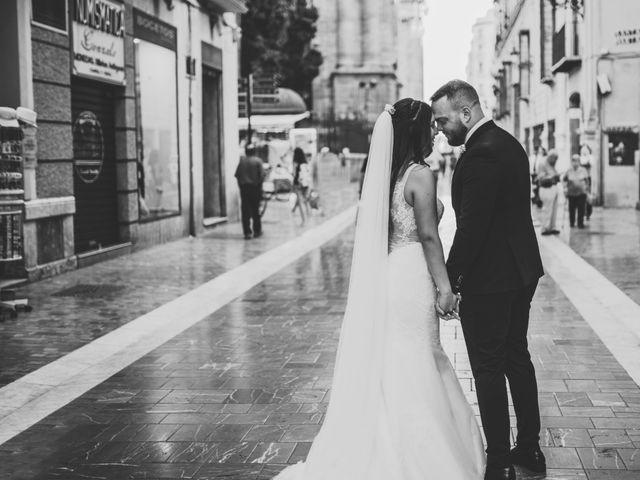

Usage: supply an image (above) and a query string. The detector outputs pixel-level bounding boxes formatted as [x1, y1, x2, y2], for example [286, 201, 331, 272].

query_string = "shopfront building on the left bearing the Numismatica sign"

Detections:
[0, 0, 246, 279]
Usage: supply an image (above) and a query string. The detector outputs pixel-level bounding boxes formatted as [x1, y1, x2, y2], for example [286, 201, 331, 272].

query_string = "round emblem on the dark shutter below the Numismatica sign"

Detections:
[73, 110, 104, 183]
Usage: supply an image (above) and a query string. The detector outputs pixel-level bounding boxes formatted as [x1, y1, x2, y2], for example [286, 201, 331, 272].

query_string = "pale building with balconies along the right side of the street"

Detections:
[496, 0, 640, 207]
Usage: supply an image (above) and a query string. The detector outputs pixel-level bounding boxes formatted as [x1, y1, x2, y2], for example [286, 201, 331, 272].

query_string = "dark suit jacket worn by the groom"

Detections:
[447, 121, 544, 294]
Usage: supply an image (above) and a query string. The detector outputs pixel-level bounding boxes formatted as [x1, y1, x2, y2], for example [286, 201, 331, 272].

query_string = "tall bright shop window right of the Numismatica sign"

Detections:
[134, 12, 180, 221]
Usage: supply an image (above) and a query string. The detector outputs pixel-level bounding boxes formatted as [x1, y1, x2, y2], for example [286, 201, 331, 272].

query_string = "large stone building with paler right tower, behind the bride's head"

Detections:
[313, 0, 423, 150]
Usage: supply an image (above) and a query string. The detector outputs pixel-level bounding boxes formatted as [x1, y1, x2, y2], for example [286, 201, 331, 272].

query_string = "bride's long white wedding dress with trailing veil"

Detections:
[276, 114, 485, 480]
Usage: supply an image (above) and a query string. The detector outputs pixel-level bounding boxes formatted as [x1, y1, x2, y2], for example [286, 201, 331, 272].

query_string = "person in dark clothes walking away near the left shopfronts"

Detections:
[236, 144, 265, 240]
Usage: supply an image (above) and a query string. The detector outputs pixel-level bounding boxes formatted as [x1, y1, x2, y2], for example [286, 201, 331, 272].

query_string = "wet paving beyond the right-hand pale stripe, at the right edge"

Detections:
[568, 208, 640, 304]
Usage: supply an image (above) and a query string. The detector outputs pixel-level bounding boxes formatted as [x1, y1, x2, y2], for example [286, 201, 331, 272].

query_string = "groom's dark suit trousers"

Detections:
[460, 281, 540, 468]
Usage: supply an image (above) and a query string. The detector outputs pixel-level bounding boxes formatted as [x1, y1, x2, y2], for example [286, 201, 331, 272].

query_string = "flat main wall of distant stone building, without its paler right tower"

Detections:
[313, 0, 401, 152]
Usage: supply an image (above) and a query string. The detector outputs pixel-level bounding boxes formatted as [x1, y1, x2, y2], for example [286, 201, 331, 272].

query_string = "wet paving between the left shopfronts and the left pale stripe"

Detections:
[0, 159, 357, 387]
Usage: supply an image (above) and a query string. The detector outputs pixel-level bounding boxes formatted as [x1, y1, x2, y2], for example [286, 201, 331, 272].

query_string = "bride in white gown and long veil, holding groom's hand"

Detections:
[276, 98, 485, 480]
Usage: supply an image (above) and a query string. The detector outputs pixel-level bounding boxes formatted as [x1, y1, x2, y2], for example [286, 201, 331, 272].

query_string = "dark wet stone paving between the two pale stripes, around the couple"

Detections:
[0, 217, 640, 480]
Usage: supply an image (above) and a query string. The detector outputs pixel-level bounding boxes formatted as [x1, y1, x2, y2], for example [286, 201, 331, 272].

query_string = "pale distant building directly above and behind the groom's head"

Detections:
[466, 9, 498, 115]
